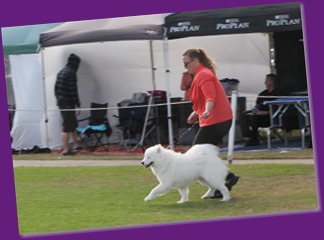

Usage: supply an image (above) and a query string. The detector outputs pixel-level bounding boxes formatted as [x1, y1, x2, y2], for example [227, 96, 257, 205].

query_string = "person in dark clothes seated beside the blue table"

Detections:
[239, 73, 280, 146]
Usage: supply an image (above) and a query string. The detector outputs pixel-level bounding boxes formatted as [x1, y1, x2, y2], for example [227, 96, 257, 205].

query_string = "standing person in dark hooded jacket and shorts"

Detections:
[54, 53, 81, 155]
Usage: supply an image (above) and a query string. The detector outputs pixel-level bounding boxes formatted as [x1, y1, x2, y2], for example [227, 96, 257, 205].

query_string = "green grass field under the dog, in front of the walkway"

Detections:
[14, 164, 318, 234]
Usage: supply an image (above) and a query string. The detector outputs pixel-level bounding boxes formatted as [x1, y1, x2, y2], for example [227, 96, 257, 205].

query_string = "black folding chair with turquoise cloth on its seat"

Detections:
[77, 103, 112, 152]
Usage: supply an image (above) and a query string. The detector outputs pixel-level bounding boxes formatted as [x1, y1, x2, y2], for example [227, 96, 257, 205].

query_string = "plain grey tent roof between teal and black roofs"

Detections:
[40, 14, 164, 47]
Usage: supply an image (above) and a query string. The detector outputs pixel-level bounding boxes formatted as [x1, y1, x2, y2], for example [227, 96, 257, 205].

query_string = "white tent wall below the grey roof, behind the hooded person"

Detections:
[42, 41, 164, 149]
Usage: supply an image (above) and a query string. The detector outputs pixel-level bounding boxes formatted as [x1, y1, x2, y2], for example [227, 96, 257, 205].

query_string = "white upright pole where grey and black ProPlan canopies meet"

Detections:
[163, 28, 174, 150]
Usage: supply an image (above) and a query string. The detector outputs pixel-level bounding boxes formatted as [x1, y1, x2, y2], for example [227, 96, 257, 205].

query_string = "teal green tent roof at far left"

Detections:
[2, 23, 60, 55]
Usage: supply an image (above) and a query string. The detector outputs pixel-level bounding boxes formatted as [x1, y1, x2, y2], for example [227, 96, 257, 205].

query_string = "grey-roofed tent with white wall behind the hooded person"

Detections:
[40, 14, 173, 148]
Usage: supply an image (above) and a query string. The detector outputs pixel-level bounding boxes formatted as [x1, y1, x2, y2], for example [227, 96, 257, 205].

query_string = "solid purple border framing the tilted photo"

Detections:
[0, 0, 324, 240]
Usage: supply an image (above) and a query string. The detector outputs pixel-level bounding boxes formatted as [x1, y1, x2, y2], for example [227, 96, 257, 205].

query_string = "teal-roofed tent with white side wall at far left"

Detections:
[1, 23, 60, 149]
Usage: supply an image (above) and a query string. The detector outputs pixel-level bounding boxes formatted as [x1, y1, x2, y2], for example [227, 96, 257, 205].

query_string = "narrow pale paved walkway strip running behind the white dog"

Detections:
[13, 159, 314, 167]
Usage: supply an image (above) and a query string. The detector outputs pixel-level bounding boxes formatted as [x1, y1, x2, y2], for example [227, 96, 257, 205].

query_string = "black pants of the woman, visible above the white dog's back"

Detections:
[193, 120, 232, 146]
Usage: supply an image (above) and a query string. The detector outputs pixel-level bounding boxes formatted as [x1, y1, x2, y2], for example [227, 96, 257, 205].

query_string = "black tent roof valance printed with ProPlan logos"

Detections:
[165, 3, 302, 39]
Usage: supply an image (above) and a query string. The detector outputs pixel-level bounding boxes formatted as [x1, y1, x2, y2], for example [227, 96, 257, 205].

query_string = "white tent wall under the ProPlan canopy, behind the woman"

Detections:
[165, 33, 270, 107]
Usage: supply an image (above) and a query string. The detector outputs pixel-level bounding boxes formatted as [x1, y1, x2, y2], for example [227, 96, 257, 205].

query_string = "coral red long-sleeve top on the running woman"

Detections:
[190, 64, 233, 127]
